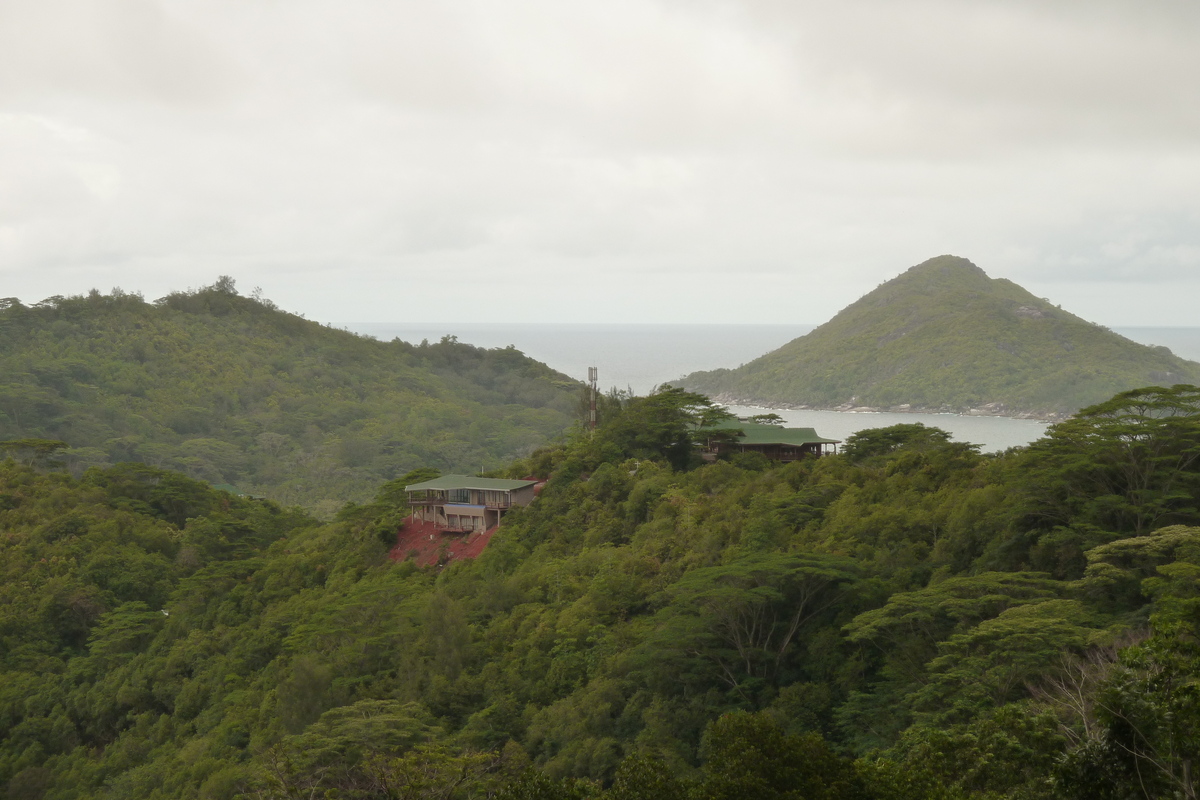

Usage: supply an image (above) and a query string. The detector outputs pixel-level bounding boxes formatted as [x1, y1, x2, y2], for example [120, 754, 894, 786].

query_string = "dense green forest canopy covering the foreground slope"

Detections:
[0, 386, 1200, 800]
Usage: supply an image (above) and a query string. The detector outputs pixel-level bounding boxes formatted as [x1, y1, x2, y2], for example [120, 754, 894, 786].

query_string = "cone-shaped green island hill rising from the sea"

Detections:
[679, 255, 1200, 417]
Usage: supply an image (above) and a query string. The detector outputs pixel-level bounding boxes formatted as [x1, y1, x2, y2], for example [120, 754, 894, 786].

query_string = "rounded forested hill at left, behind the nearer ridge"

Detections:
[0, 278, 578, 512]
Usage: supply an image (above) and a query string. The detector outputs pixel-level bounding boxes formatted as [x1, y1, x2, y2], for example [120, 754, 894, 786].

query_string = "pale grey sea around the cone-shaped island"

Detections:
[341, 323, 1200, 452]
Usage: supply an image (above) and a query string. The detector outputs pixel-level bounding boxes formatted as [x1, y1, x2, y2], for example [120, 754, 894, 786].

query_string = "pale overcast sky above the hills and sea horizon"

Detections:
[0, 0, 1200, 325]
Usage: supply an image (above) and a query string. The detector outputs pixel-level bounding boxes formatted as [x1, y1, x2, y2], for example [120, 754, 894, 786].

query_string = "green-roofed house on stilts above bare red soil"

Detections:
[404, 475, 538, 534]
